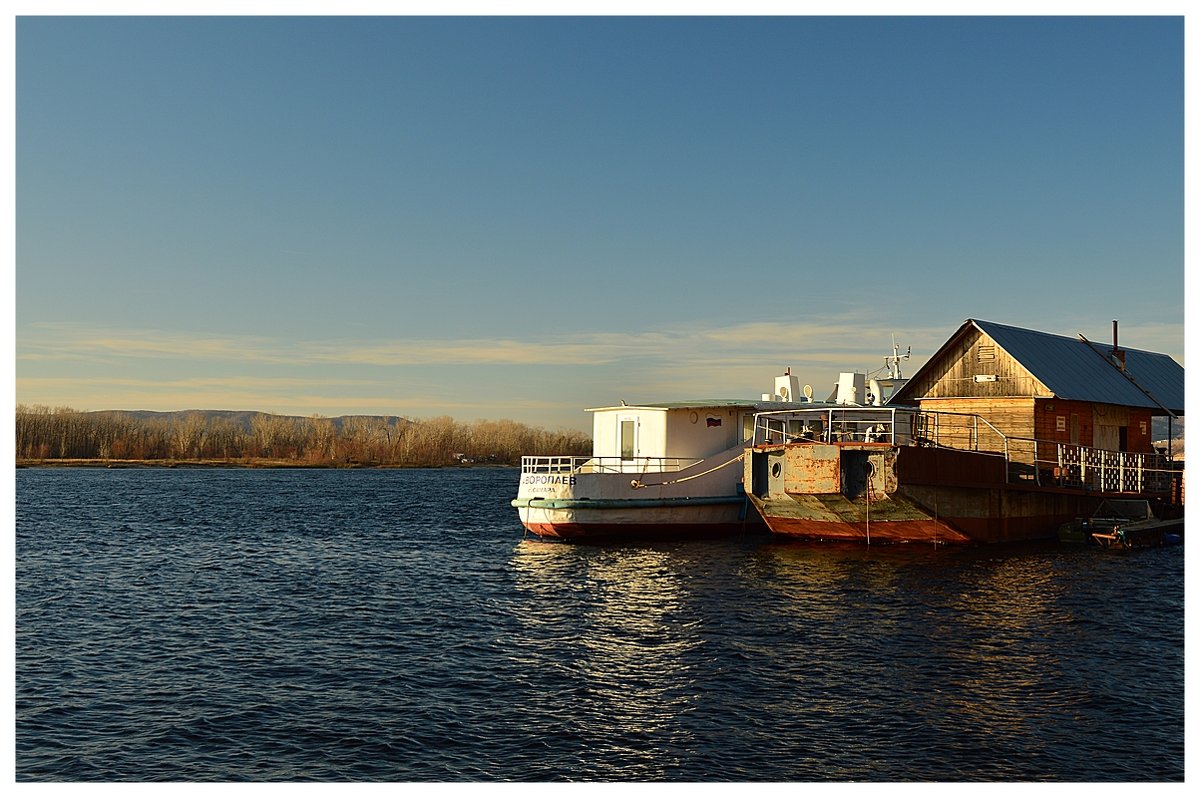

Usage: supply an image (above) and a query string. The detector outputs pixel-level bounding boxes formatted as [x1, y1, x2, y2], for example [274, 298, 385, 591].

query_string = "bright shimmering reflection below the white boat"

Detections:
[512, 540, 700, 779]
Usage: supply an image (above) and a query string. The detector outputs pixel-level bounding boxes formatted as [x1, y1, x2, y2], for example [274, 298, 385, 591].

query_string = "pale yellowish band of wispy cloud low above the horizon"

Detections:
[16, 313, 1183, 427]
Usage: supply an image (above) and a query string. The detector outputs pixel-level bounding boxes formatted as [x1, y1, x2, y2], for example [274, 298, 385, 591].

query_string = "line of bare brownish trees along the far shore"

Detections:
[9, 406, 592, 467]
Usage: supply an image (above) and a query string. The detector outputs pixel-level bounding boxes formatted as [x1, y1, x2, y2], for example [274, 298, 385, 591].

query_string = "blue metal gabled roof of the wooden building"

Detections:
[910, 319, 1183, 415]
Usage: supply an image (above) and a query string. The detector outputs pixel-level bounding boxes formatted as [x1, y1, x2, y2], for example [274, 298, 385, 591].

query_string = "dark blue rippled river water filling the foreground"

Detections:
[16, 469, 1184, 781]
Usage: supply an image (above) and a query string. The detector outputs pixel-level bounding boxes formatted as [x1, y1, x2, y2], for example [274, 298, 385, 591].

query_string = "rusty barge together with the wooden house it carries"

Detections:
[743, 319, 1183, 544]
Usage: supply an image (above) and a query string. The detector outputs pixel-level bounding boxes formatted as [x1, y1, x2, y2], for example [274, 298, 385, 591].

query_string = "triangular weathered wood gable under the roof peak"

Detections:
[912, 330, 1050, 398]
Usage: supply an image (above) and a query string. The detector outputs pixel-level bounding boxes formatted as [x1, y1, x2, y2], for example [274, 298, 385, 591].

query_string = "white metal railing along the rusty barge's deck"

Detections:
[752, 406, 1182, 496]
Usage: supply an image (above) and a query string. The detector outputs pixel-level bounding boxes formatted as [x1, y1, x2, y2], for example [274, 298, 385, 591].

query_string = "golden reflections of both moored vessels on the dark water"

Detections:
[501, 540, 1137, 780]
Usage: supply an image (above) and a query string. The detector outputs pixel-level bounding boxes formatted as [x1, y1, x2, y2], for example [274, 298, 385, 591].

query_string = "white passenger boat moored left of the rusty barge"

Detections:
[512, 348, 907, 540]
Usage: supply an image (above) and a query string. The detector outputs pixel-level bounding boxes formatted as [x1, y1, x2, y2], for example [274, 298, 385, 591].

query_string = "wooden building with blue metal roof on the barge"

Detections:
[892, 319, 1184, 484]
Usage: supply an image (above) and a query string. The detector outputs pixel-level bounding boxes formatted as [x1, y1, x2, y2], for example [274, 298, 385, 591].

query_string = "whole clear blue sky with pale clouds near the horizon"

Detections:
[14, 10, 1184, 430]
